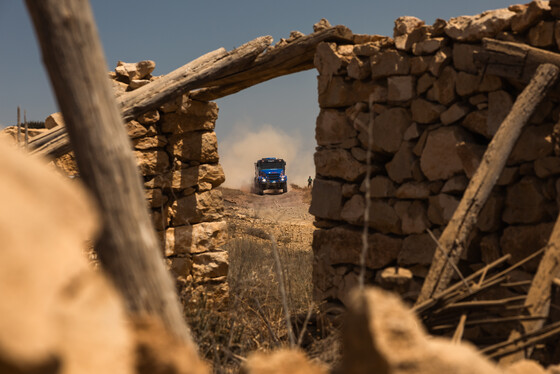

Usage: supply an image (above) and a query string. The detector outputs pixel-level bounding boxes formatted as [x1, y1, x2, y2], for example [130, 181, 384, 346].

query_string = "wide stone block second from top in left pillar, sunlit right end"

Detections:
[167, 131, 219, 163]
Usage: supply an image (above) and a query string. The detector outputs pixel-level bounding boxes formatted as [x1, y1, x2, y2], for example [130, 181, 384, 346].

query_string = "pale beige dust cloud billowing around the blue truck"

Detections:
[219, 124, 315, 190]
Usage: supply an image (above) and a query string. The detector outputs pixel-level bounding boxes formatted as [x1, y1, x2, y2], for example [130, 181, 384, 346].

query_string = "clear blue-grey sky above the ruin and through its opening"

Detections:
[0, 0, 514, 186]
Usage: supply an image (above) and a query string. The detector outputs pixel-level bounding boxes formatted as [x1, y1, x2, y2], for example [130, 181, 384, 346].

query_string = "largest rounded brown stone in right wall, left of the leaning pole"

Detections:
[420, 126, 469, 181]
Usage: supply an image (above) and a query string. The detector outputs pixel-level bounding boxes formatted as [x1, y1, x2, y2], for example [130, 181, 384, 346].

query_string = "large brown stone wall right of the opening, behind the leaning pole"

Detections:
[310, 1, 560, 303]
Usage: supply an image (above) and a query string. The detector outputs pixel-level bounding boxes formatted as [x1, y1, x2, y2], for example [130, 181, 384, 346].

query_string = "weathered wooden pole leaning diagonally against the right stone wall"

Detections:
[416, 64, 559, 305]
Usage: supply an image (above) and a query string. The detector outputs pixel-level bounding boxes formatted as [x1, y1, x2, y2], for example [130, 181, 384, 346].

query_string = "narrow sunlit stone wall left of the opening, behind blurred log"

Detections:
[45, 61, 228, 300]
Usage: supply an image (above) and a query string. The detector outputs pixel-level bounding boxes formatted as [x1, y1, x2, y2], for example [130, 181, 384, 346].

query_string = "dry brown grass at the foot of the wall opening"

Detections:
[187, 232, 338, 373]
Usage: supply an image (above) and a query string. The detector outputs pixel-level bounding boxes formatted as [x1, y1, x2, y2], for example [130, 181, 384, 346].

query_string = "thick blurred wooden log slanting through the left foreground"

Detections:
[26, 0, 194, 344]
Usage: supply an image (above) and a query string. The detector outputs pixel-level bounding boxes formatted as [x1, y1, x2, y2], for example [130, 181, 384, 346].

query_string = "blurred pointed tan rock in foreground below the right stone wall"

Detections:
[341, 288, 503, 374]
